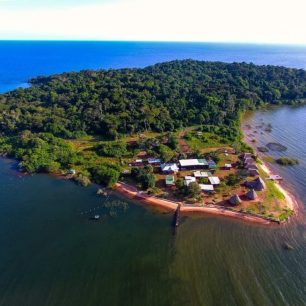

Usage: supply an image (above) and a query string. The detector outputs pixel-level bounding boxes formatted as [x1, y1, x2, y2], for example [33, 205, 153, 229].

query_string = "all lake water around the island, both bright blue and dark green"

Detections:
[0, 42, 306, 306]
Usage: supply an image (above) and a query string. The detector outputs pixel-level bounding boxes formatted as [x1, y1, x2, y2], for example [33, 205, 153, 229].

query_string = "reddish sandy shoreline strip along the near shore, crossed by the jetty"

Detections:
[115, 183, 272, 225]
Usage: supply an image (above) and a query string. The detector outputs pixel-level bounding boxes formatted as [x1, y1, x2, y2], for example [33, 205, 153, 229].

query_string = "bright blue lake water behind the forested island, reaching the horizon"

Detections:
[0, 41, 306, 92]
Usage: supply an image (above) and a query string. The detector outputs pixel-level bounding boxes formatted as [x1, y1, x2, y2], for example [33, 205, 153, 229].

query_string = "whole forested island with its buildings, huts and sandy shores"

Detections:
[0, 60, 306, 222]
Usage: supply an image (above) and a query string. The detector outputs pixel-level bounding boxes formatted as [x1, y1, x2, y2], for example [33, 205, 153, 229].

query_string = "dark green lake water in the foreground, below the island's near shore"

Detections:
[0, 160, 306, 306]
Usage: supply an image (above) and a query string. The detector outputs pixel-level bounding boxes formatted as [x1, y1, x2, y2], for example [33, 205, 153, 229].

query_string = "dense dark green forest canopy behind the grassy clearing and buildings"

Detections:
[0, 60, 306, 139]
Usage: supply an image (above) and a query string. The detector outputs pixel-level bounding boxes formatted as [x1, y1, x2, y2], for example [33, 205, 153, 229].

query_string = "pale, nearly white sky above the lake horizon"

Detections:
[0, 0, 306, 45]
